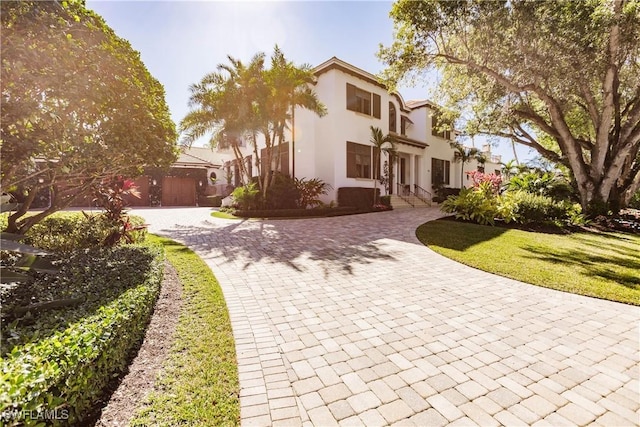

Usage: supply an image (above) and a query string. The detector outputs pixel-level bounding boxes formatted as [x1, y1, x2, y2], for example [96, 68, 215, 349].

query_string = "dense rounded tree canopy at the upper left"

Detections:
[0, 1, 177, 233]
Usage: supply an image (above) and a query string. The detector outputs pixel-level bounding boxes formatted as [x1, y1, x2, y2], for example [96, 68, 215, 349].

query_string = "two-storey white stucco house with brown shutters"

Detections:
[212, 57, 500, 207]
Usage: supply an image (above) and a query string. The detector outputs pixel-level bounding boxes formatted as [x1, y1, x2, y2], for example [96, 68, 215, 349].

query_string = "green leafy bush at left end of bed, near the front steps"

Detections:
[441, 188, 498, 225]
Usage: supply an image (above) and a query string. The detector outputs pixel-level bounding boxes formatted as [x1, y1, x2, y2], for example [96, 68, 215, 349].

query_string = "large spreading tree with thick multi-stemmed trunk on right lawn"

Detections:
[380, 0, 640, 214]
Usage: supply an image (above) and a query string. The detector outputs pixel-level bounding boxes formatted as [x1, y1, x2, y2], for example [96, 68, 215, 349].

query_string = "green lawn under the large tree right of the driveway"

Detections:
[416, 220, 640, 305]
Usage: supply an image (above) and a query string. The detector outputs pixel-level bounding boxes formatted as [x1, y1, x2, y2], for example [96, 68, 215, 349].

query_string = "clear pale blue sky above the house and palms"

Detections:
[86, 0, 533, 160]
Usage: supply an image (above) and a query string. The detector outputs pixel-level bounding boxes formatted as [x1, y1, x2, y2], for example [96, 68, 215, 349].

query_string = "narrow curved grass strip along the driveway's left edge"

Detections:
[131, 236, 240, 426]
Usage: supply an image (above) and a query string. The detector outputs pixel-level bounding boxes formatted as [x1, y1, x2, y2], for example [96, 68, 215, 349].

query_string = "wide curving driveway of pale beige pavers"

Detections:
[135, 208, 640, 426]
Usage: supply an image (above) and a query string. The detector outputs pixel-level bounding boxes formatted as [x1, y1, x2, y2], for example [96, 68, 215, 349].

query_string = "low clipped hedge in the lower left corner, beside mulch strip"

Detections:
[0, 246, 164, 425]
